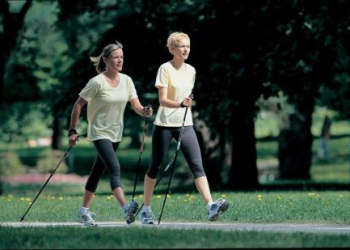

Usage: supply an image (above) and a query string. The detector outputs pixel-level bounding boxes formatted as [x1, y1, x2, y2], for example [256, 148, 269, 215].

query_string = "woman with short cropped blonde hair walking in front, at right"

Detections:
[139, 32, 229, 224]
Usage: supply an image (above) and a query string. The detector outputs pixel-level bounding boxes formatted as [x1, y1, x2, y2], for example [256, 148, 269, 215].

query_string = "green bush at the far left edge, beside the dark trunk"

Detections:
[0, 151, 28, 176]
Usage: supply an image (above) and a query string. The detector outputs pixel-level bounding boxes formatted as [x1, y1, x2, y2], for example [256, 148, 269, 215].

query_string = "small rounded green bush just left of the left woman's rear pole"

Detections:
[35, 148, 68, 174]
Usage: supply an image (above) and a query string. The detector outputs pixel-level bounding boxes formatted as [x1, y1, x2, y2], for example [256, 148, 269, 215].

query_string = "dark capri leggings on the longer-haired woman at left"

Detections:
[85, 139, 122, 193]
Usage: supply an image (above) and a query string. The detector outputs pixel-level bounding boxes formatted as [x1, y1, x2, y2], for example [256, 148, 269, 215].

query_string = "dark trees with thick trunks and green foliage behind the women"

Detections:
[0, 0, 350, 189]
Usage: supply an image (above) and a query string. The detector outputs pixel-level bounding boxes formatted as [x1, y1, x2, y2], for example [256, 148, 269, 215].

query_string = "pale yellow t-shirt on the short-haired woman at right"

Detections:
[154, 62, 196, 127]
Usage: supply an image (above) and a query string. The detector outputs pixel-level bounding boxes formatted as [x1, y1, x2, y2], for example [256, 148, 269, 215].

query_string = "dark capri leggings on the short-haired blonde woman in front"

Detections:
[147, 125, 205, 179]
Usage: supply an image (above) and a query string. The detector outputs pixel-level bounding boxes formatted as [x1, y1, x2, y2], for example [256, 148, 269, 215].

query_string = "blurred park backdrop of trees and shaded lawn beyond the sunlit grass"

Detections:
[0, 0, 350, 193]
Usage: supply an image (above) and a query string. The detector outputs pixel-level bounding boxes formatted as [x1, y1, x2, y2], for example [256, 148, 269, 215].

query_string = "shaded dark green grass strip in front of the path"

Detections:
[0, 227, 349, 249]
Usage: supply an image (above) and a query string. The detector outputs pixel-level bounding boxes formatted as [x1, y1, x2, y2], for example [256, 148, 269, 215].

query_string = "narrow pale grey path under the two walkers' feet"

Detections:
[0, 221, 350, 234]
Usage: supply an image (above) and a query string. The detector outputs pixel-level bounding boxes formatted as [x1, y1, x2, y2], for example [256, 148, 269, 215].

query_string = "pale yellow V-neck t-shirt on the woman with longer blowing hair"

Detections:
[79, 73, 137, 142]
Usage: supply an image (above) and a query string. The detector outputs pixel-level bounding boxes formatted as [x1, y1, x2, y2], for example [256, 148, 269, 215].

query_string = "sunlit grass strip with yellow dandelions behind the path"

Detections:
[0, 191, 350, 224]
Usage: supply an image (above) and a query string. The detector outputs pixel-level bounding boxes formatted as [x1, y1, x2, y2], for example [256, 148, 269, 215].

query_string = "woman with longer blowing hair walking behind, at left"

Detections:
[68, 42, 153, 226]
